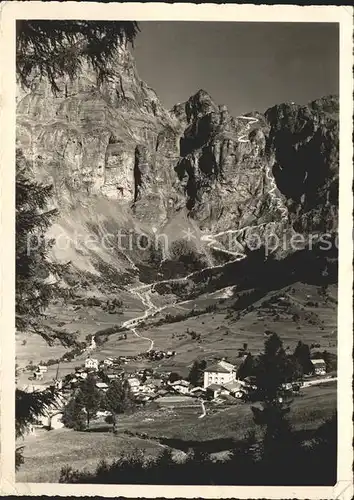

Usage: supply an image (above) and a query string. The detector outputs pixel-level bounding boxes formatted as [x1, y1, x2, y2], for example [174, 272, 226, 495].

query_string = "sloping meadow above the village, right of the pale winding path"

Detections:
[97, 283, 337, 375]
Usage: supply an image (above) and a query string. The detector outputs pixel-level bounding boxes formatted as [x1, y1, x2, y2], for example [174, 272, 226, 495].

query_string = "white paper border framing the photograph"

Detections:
[0, 1, 353, 499]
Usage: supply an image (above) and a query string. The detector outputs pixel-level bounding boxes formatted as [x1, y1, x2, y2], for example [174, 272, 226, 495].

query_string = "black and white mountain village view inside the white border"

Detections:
[1, 2, 352, 498]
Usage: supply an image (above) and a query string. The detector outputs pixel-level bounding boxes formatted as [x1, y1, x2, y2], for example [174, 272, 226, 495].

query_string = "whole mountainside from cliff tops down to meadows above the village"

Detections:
[17, 41, 339, 375]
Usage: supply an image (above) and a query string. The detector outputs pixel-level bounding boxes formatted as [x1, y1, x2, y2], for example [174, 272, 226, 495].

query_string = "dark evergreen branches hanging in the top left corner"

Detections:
[16, 19, 139, 92]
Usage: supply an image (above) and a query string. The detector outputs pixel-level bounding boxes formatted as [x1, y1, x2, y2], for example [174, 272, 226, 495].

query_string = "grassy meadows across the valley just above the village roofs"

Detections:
[16, 283, 337, 385]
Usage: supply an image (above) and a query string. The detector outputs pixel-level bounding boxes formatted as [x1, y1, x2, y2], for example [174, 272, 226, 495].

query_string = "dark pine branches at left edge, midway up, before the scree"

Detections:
[16, 150, 69, 343]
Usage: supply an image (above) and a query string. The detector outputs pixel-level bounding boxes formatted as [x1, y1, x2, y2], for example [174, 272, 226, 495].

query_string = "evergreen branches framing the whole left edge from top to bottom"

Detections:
[16, 20, 138, 465]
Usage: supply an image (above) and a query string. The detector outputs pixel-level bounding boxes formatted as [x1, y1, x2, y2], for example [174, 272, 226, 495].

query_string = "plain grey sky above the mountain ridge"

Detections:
[133, 21, 339, 116]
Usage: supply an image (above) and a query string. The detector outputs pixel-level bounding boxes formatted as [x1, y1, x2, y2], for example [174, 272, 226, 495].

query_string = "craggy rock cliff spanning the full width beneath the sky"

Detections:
[17, 41, 339, 280]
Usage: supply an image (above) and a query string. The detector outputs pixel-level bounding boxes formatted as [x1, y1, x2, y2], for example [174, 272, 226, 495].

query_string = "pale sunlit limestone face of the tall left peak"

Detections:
[17, 40, 179, 217]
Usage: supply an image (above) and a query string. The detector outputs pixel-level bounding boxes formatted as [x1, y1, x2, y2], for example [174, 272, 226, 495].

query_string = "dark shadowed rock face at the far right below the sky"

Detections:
[265, 96, 339, 235]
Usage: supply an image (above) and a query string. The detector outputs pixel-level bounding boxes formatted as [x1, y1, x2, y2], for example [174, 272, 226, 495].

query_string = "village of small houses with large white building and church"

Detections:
[22, 337, 336, 433]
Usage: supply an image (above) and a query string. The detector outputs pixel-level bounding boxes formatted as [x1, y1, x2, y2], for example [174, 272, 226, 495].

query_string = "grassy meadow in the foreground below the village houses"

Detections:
[17, 383, 336, 482]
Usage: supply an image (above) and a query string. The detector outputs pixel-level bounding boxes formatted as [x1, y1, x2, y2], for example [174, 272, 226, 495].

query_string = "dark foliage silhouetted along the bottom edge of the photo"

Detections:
[60, 418, 336, 486]
